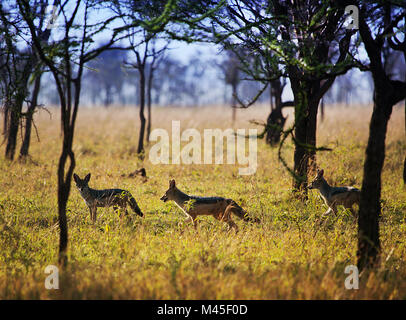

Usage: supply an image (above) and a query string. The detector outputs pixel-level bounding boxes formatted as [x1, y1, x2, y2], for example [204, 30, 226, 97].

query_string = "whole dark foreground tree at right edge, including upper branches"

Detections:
[357, 1, 406, 269]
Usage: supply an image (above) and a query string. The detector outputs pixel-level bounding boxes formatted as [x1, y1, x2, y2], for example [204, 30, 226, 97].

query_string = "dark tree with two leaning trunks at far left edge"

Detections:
[0, 0, 51, 160]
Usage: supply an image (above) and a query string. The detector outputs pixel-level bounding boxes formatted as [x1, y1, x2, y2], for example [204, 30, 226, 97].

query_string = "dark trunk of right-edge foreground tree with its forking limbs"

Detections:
[357, 8, 406, 270]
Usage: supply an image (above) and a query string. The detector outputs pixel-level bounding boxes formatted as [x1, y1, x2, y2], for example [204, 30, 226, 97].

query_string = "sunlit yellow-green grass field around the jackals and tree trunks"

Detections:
[0, 106, 406, 299]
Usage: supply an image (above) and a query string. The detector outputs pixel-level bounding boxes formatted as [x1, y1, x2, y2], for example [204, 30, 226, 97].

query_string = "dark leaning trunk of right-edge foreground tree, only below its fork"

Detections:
[357, 92, 393, 270]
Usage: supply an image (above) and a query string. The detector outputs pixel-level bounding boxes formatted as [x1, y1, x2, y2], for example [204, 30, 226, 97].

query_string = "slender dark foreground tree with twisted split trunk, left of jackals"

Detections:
[17, 0, 141, 265]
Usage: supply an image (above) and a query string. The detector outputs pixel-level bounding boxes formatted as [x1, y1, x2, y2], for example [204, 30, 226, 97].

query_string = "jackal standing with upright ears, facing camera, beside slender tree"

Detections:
[73, 173, 144, 222]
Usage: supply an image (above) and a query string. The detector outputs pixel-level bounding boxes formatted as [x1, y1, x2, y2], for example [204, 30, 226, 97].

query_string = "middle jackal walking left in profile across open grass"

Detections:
[161, 180, 259, 231]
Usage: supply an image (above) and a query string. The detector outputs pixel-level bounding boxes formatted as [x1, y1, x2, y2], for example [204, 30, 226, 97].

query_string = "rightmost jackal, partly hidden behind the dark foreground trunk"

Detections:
[308, 170, 361, 216]
